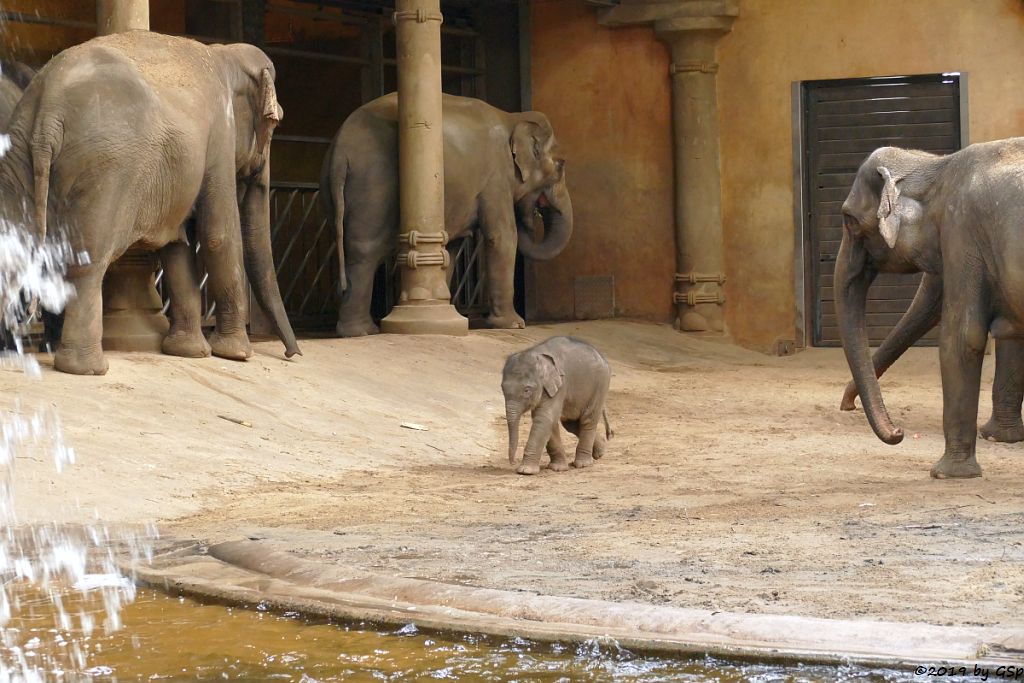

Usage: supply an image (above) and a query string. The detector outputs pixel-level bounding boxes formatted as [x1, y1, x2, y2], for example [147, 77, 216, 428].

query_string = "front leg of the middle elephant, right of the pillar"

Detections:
[480, 196, 526, 330]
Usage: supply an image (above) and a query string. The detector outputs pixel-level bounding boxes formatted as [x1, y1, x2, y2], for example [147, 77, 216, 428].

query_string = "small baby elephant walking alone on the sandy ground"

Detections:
[502, 337, 612, 474]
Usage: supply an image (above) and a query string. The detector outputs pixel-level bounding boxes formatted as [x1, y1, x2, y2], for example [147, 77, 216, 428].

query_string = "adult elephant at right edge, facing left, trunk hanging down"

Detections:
[836, 138, 1024, 478]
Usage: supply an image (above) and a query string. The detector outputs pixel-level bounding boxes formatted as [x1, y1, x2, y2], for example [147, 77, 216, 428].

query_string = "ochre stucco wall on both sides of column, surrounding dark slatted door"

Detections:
[531, 0, 1024, 351]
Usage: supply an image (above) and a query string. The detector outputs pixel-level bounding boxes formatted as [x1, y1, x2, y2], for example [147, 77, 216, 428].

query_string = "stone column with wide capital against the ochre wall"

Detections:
[600, 0, 739, 332]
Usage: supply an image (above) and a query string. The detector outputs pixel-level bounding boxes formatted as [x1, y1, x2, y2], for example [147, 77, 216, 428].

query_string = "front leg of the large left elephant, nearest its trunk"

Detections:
[196, 181, 253, 360]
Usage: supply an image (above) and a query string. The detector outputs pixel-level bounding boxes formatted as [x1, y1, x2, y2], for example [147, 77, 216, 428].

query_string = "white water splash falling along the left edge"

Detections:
[0, 197, 157, 683]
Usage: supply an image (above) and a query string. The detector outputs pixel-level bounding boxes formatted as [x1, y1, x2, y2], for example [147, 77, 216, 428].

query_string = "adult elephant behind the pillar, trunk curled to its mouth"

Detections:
[321, 93, 572, 337]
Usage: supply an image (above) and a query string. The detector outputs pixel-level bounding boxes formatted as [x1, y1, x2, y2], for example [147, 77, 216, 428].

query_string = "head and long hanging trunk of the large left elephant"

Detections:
[214, 43, 301, 357]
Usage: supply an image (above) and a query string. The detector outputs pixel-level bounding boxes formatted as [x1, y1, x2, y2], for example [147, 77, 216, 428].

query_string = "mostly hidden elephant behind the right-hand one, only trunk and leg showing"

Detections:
[840, 273, 1024, 443]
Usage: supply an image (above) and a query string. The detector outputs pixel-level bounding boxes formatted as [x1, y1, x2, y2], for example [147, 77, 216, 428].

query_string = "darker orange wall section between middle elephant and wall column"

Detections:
[527, 0, 675, 322]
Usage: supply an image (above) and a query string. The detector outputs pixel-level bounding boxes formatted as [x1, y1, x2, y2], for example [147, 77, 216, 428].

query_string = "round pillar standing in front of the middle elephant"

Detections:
[381, 0, 469, 335]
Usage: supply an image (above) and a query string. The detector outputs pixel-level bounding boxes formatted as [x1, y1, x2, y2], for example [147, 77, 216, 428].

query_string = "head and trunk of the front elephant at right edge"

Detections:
[835, 147, 944, 444]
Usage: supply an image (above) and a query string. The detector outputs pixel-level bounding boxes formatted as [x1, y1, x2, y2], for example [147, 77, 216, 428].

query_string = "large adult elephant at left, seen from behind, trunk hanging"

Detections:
[0, 31, 298, 375]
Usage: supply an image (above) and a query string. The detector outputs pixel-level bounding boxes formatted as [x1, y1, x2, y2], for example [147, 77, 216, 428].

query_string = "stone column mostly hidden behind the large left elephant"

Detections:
[96, 0, 169, 352]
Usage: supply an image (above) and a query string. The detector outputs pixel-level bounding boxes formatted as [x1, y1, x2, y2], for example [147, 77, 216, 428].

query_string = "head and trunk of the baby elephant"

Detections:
[502, 349, 565, 465]
